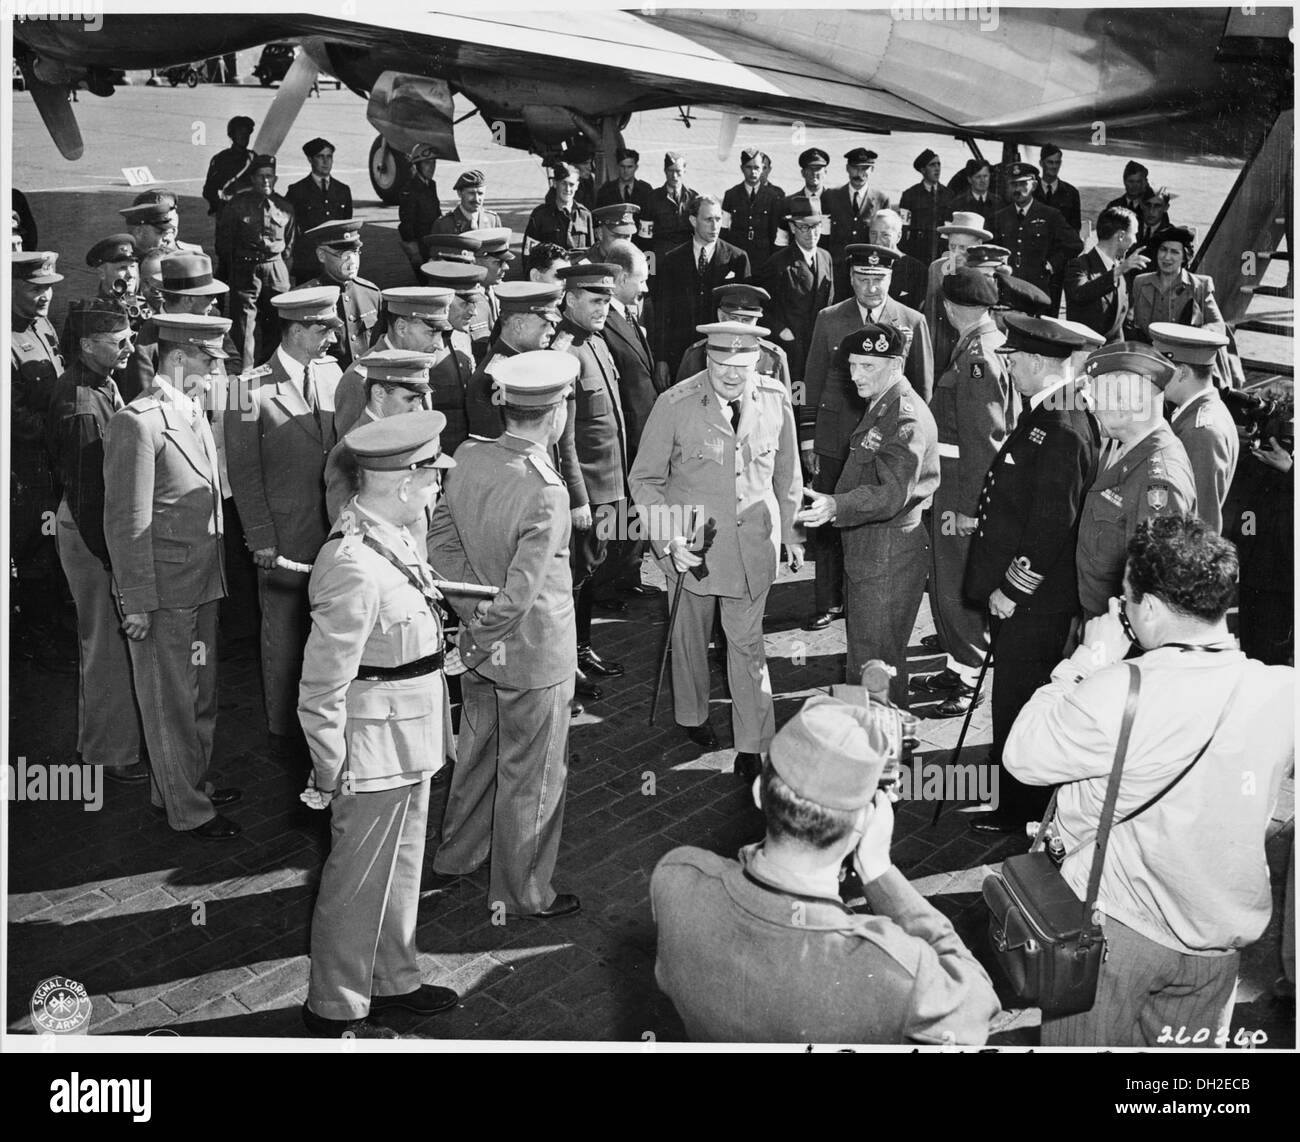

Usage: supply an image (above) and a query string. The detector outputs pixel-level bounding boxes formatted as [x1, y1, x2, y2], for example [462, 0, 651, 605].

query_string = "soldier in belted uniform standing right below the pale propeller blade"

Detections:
[217, 155, 298, 367]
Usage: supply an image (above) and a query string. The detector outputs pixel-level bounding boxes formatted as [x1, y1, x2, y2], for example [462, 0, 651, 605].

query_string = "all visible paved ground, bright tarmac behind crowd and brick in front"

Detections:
[5, 78, 1295, 1047]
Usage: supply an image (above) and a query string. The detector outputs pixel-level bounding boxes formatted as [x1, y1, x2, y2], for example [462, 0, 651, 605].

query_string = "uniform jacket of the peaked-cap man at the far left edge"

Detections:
[9, 317, 64, 512]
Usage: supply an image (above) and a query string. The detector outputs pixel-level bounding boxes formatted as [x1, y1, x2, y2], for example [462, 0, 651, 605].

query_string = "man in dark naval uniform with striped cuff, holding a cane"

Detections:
[965, 313, 1101, 836]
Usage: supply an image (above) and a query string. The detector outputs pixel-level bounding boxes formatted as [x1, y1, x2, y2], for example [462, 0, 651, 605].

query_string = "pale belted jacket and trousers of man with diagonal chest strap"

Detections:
[295, 499, 455, 1020]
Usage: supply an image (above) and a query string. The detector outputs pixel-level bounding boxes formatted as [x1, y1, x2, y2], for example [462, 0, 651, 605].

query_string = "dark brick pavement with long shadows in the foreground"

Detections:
[7, 554, 1294, 1046]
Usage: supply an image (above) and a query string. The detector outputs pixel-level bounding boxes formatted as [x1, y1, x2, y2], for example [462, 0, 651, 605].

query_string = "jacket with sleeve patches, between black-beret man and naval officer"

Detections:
[930, 316, 1015, 518]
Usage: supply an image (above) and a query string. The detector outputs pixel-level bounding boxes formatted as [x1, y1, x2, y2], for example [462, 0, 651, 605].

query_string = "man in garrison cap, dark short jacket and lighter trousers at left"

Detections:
[46, 298, 148, 782]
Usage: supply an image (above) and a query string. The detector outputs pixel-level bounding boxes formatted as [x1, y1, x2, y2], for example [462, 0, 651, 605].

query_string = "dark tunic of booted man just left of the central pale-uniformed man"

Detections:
[551, 317, 628, 507]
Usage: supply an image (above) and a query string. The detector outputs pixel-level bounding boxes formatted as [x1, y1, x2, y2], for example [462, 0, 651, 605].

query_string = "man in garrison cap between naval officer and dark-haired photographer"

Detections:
[1075, 341, 1197, 620]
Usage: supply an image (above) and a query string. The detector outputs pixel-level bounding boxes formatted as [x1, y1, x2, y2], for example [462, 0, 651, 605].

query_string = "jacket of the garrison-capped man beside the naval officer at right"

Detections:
[1076, 420, 1196, 615]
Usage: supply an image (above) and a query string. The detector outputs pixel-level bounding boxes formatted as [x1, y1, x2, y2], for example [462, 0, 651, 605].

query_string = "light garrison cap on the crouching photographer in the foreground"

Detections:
[768, 695, 889, 810]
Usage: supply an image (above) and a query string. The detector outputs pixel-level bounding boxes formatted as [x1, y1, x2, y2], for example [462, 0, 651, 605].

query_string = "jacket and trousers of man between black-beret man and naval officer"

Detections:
[930, 315, 1017, 670]
